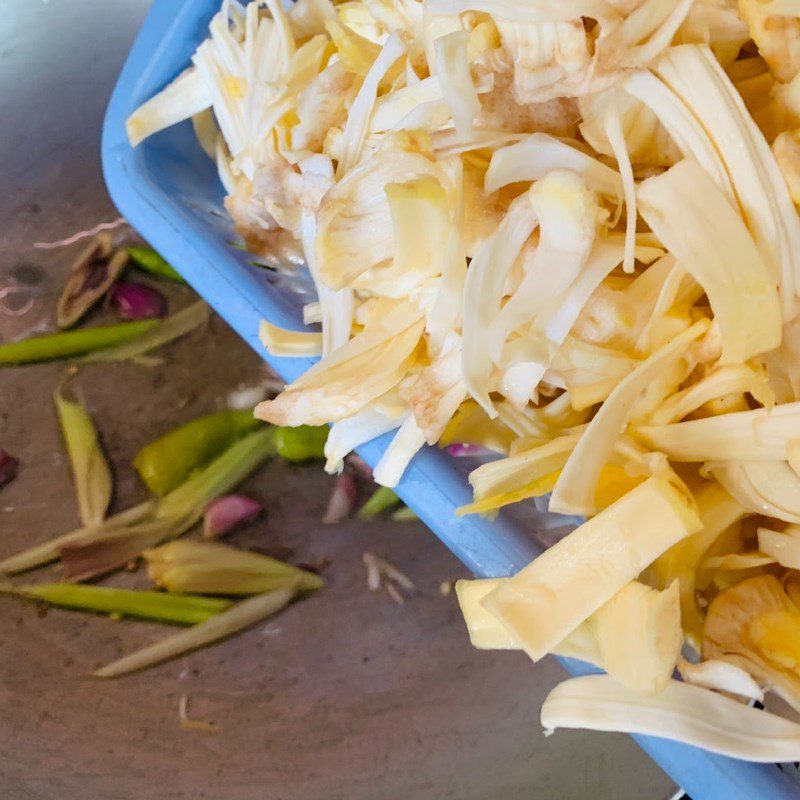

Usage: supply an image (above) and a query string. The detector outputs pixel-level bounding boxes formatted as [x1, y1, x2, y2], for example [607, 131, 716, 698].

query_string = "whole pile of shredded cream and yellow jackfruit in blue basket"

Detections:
[128, 0, 800, 761]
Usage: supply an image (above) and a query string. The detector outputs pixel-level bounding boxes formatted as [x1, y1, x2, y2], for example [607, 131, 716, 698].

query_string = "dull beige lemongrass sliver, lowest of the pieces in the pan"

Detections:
[94, 588, 295, 678]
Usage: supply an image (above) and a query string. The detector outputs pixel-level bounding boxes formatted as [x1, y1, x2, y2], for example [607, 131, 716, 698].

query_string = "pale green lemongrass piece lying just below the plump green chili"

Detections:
[156, 426, 275, 519]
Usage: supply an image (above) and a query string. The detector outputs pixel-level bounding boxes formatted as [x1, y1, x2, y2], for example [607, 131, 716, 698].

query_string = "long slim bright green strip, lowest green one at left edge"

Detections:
[4, 583, 232, 625]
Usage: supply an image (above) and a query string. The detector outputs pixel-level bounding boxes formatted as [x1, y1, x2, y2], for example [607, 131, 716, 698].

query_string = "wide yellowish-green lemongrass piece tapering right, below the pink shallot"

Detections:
[144, 539, 324, 595]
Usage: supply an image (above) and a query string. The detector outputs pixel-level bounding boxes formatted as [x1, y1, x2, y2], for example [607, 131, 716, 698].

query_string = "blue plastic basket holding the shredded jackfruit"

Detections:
[102, 0, 800, 800]
